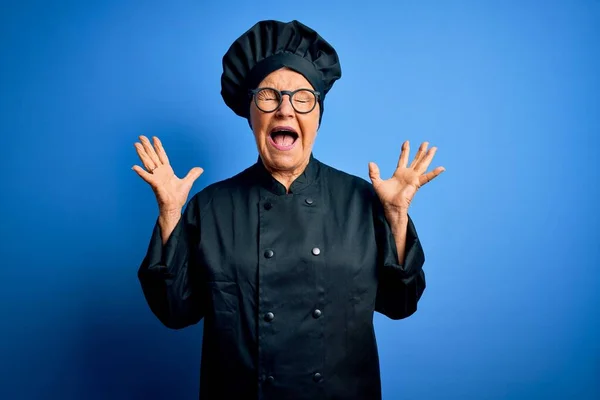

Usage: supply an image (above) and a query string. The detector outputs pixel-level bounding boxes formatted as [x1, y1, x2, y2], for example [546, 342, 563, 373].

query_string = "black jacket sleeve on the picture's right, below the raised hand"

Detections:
[375, 202, 425, 319]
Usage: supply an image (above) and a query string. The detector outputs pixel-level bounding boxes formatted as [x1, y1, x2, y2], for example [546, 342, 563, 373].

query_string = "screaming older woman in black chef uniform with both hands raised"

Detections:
[133, 21, 444, 400]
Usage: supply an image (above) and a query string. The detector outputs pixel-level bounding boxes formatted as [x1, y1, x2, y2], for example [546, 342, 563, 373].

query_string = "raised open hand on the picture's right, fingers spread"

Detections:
[369, 141, 445, 214]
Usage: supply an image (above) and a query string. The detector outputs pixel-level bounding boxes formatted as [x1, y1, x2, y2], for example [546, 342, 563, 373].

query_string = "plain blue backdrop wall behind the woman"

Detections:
[0, 0, 600, 399]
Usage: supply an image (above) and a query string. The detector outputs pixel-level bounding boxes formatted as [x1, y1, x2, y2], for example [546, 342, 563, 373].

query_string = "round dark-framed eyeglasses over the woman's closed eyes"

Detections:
[250, 88, 320, 114]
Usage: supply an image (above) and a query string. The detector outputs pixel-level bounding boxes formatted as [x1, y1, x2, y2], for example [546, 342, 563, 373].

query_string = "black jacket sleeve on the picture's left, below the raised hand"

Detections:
[138, 198, 204, 329]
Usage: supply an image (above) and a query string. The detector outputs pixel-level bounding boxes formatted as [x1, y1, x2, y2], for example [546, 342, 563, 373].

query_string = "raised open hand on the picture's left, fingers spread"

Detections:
[132, 135, 204, 216]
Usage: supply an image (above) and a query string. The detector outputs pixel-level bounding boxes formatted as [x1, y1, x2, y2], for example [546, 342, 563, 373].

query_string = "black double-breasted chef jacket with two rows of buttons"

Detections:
[138, 154, 425, 400]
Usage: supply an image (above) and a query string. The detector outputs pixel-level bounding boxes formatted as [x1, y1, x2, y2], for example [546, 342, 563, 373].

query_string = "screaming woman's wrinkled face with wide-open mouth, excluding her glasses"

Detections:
[250, 68, 319, 174]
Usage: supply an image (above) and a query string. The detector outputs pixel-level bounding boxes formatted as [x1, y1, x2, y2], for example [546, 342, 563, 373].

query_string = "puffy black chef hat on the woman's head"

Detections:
[221, 20, 342, 122]
